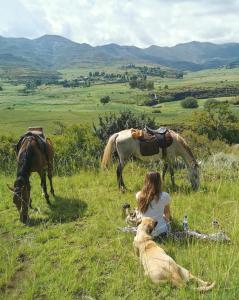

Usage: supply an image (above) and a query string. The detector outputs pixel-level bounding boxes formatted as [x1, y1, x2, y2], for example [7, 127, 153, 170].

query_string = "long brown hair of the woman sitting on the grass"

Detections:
[138, 172, 162, 213]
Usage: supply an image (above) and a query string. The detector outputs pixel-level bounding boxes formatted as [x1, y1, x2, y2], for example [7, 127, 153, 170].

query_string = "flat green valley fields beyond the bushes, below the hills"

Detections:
[0, 67, 239, 135]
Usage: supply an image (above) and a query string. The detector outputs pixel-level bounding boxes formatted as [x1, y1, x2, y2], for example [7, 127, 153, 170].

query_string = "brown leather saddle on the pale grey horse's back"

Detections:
[134, 126, 173, 158]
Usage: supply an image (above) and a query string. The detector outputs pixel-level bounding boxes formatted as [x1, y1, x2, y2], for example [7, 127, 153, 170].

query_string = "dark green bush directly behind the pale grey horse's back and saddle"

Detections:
[93, 111, 156, 143]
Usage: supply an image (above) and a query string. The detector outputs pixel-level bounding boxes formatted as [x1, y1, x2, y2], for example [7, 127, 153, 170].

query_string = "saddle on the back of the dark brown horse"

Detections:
[16, 127, 48, 160]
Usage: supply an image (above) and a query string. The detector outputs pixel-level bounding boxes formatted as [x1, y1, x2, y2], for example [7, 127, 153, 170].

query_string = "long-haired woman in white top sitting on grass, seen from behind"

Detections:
[136, 172, 171, 237]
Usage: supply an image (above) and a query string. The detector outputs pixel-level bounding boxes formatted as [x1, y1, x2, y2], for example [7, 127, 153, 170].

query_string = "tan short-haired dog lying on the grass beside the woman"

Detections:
[133, 217, 215, 292]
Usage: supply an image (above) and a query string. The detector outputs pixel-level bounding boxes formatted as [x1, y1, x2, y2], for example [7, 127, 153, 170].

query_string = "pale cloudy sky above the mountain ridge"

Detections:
[0, 0, 239, 47]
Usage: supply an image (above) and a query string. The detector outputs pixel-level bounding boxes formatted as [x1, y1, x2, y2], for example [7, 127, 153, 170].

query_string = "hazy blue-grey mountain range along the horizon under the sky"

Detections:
[0, 35, 239, 70]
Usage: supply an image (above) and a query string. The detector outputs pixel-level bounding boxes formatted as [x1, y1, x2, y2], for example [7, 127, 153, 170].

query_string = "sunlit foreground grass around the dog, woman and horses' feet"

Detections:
[0, 163, 239, 300]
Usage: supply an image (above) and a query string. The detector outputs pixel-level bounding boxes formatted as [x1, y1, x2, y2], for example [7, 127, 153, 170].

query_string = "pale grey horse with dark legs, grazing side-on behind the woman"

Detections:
[102, 129, 199, 191]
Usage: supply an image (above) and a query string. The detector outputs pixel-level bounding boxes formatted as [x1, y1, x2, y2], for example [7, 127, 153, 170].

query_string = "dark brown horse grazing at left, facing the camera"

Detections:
[8, 134, 54, 223]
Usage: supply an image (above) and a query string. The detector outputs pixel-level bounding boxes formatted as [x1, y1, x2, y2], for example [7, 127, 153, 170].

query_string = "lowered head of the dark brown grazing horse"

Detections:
[8, 176, 30, 223]
